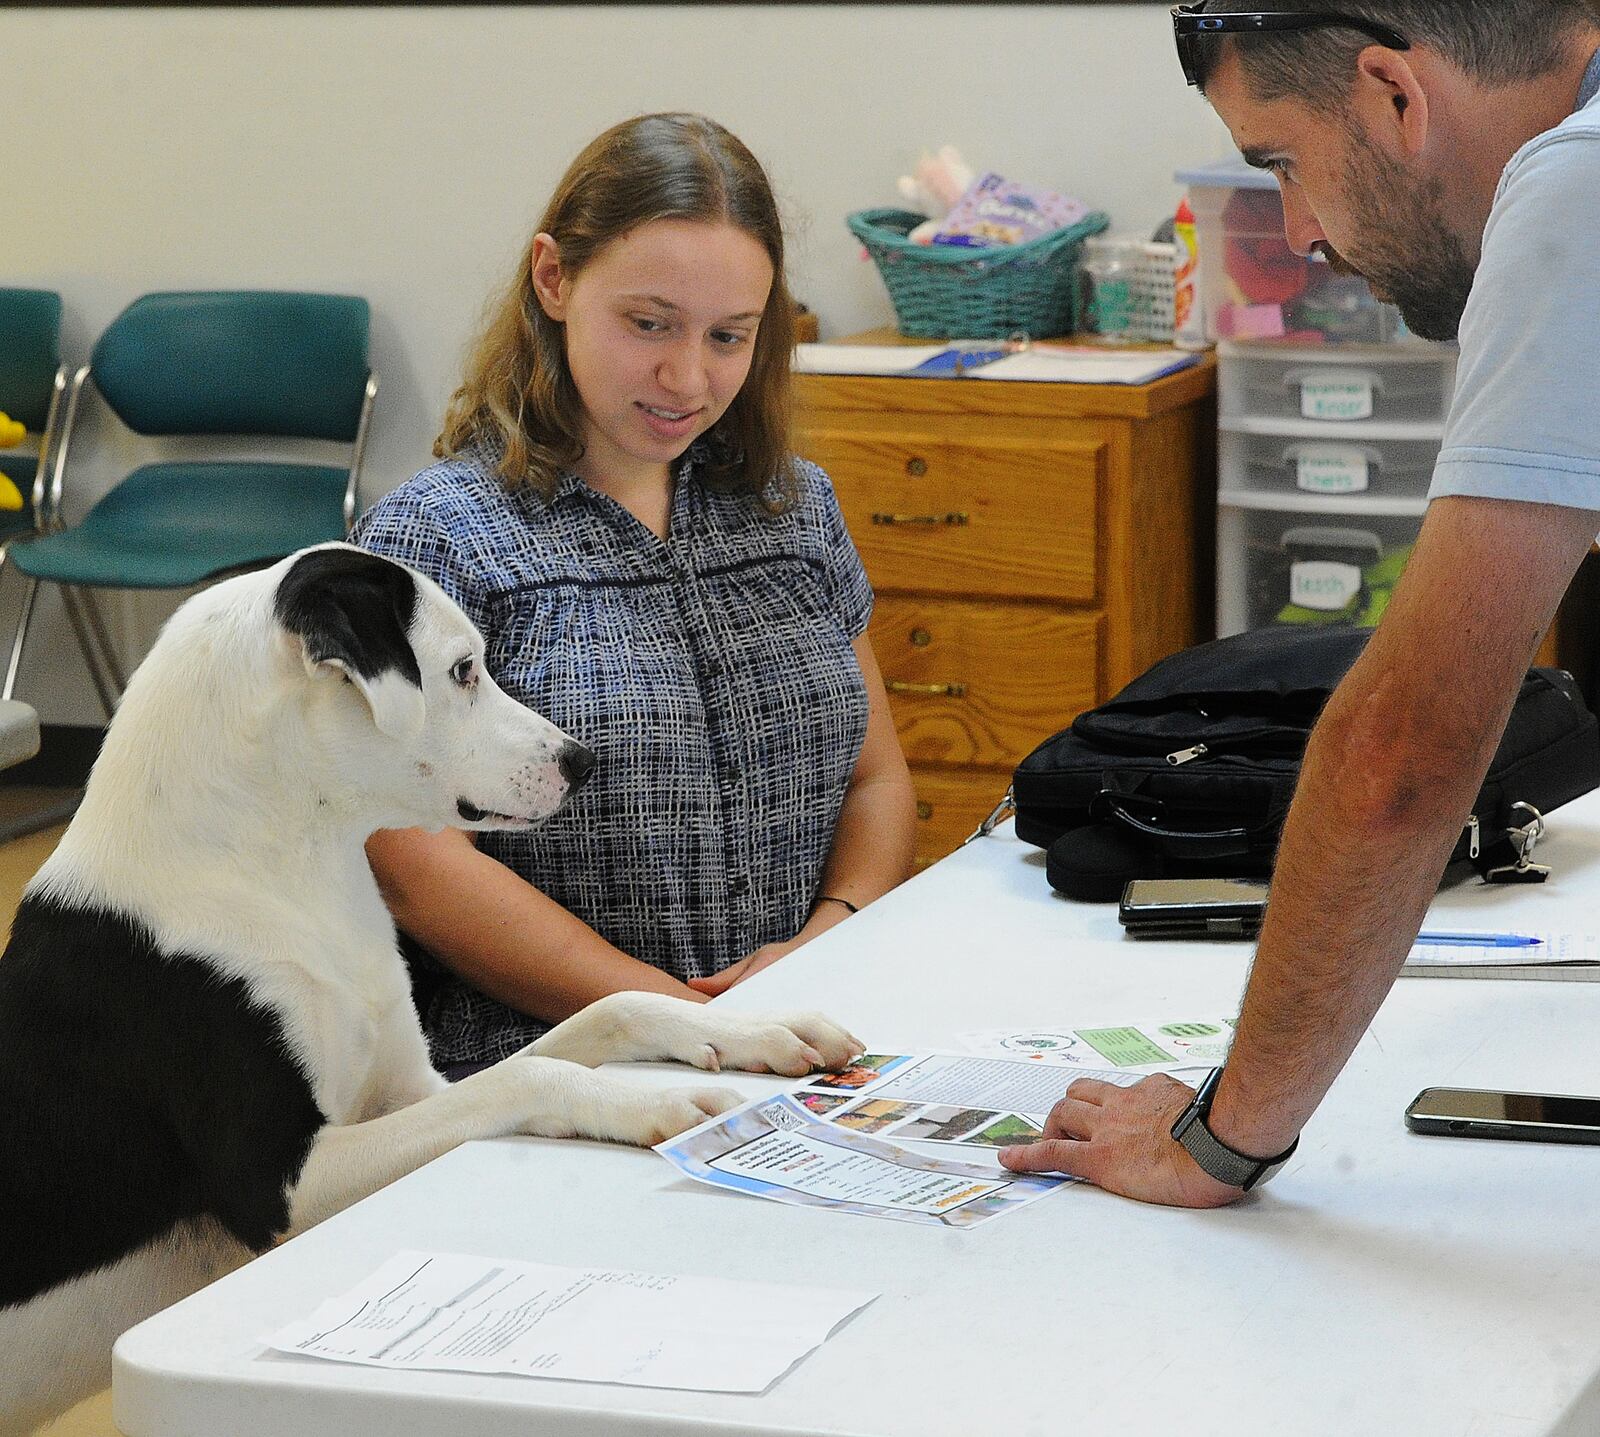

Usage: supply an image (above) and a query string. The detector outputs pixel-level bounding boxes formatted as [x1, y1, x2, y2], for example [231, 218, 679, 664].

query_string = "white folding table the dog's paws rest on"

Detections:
[115, 795, 1600, 1437]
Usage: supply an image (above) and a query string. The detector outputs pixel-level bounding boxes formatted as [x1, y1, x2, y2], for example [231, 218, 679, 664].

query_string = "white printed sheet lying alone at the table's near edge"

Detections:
[266, 1251, 877, 1392]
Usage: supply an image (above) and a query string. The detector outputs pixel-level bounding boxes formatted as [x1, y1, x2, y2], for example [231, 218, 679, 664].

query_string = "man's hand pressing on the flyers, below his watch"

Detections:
[1000, 1074, 1245, 1208]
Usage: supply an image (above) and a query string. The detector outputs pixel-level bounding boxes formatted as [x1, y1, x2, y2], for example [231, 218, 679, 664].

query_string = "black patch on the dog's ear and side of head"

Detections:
[274, 549, 422, 688]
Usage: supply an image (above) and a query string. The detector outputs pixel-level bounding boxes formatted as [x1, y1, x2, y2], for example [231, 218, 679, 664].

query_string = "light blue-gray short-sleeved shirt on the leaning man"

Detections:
[1429, 54, 1600, 510]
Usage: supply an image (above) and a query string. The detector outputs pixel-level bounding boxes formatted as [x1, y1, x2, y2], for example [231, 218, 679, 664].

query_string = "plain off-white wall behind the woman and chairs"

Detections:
[0, 3, 1227, 722]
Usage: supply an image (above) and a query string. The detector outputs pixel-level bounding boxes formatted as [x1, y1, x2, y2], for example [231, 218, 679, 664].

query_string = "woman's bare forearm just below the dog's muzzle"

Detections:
[366, 829, 710, 1023]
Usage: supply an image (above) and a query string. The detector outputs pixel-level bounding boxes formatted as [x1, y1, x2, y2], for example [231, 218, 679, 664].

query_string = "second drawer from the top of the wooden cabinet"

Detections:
[872, 594, 1101, 767]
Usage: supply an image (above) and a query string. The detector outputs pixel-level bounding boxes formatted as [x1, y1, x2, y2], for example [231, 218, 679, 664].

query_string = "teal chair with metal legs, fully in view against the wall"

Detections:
[5, 291, 378, 719]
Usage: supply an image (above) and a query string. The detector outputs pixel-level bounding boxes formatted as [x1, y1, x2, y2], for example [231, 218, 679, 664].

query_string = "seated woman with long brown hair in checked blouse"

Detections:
[357, 115, 914, 1067]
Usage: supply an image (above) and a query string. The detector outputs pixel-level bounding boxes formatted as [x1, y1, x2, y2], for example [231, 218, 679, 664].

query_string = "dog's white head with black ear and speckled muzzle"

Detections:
[272, 544, 595, 829]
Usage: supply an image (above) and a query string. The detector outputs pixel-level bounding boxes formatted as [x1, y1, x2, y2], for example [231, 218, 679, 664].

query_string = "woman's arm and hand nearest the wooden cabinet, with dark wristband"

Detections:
[690, 634, 917, 997]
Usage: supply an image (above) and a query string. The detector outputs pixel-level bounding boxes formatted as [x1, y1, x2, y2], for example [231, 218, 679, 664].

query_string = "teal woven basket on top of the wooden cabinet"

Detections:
[845, 210, 1110, 339]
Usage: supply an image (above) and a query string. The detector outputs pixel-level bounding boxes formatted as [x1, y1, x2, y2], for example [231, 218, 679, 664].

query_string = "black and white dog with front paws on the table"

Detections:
[0, 544, 861, 1432]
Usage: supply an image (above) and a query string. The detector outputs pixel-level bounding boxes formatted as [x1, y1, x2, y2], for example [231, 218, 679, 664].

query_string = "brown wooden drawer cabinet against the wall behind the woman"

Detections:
[797, 336, 1216, 866]
